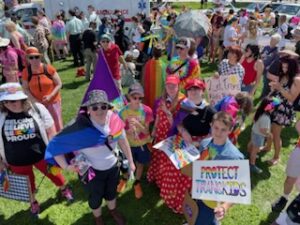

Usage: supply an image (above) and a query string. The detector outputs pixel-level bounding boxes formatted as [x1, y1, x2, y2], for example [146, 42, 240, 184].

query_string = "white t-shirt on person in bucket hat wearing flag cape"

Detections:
[79, 111, 125, 170]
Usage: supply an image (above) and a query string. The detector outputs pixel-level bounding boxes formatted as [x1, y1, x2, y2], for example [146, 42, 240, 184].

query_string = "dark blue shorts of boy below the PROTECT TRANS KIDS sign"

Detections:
[195, 200, 219, 225]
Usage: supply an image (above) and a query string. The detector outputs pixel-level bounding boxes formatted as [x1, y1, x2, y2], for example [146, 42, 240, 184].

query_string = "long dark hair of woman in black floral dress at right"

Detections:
[279, 56, 298, 88]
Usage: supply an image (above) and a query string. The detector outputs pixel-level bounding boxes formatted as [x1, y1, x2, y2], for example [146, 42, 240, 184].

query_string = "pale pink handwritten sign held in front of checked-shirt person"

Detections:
[205, 75, 241, 105]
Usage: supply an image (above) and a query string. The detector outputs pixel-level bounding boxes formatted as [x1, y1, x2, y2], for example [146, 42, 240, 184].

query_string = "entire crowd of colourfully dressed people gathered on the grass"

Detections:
[0, 1, 300, 225]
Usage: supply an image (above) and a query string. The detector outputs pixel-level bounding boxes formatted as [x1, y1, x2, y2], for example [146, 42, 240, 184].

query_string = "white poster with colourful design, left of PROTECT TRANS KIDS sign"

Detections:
[153, 135, 199, 169]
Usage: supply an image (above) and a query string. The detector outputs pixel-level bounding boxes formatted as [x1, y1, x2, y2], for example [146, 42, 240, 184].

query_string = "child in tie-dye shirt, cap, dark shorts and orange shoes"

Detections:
[118, 83, 153, 199]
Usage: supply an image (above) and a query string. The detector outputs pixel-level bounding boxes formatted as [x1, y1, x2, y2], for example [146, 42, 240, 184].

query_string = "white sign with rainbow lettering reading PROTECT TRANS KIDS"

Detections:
[192, 160, 251, 204]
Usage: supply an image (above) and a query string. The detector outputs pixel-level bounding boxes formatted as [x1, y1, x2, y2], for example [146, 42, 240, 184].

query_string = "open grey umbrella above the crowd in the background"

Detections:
[174, 10, 211, 38]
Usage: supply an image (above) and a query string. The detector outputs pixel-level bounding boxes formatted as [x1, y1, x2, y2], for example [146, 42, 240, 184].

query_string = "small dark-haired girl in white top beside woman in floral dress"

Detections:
[248, 98, 274, 174]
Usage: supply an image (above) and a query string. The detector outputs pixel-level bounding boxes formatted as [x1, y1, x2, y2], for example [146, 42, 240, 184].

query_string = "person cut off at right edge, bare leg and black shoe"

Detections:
[272, 120, 300, 212]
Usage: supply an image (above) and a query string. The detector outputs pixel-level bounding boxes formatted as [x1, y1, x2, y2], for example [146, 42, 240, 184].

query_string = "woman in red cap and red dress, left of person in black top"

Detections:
[147, 75, 184, 188]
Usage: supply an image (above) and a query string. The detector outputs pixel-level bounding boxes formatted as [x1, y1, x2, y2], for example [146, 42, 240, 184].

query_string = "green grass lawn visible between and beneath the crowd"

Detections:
[0, 1, 297, 225]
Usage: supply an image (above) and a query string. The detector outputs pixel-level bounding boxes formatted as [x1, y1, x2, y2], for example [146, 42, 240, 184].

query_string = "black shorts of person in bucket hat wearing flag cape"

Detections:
[84, 165, 120, 209]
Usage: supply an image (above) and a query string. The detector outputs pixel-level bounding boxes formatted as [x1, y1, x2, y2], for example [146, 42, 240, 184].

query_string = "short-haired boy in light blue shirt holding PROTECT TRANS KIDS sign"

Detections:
[195, 112, 244, 225]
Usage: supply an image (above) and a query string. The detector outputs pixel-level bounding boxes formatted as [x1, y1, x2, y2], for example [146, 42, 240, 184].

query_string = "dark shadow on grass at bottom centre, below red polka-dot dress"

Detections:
[72, 180, 183, 225]
